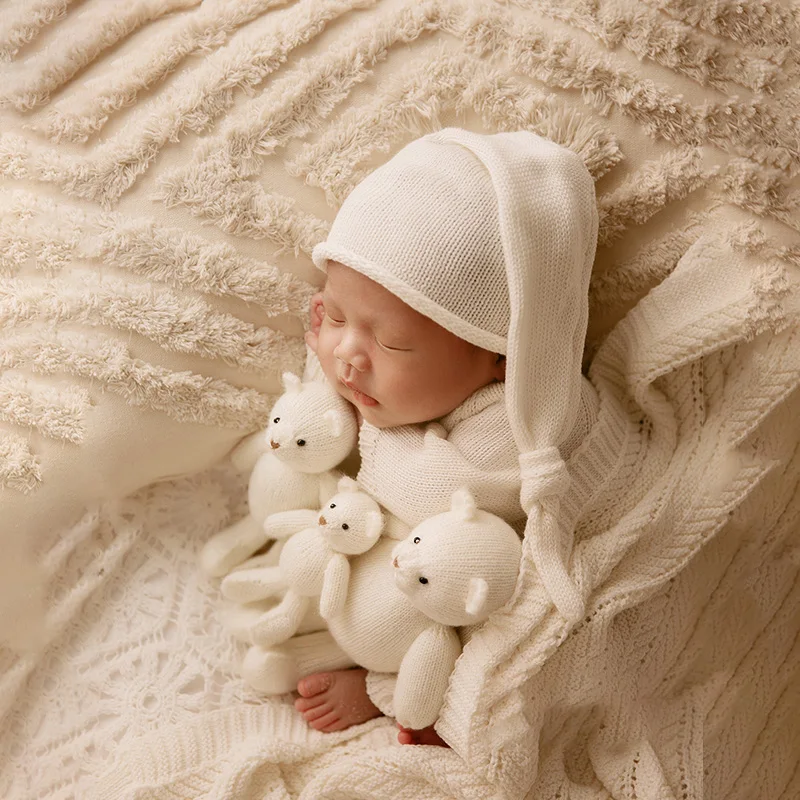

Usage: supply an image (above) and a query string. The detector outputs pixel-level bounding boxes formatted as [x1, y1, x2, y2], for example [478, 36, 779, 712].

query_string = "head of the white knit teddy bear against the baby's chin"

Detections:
[264, 372, 358, 474]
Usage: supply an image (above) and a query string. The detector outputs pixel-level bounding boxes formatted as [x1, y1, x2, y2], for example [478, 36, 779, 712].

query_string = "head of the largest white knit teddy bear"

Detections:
[392, 489, 522, 627]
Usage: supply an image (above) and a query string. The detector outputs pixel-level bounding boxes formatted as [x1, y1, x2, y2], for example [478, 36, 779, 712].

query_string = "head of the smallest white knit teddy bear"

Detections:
[317, 476, 383, 555]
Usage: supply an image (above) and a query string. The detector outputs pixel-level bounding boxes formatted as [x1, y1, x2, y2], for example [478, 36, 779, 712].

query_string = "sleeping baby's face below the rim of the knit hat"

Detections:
[317, 261, 505, 428]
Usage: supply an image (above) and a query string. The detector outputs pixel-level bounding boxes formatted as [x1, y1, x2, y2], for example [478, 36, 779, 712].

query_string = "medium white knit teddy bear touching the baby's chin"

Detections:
[200, 372, 358, 577]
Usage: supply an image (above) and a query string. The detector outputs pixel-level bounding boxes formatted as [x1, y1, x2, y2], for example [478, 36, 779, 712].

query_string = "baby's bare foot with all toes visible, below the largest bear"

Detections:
[294, 669, 381, 733]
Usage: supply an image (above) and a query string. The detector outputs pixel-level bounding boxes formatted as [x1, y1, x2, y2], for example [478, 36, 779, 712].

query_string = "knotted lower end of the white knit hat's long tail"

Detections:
[519, 447, 584, 622]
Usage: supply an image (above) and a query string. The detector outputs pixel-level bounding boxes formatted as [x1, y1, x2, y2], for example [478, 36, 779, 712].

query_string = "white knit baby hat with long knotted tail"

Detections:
[312, 128, 598, 620]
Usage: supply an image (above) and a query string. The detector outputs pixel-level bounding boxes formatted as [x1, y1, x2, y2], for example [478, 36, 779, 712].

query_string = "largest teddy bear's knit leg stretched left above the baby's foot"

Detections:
[242, 631, 355, 695]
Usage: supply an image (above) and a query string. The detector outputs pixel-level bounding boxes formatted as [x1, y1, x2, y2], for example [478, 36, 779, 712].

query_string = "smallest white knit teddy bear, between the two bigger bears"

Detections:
[221, 476, 383, 647]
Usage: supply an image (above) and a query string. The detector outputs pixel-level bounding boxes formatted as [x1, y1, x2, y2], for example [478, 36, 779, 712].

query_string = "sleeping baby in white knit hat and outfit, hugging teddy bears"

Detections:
[284, 128, 597, 744]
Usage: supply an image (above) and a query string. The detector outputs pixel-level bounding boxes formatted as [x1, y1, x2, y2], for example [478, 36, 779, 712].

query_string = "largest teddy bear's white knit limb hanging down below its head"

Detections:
[394, 624, 461, 730]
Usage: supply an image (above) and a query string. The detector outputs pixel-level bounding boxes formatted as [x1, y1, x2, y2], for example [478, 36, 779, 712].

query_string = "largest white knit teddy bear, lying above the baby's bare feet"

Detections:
[242, 489, 522, 730]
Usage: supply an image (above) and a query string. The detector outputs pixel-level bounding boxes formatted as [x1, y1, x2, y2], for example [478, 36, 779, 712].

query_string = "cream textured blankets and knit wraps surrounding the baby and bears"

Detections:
[0, 0, 800, 800]
